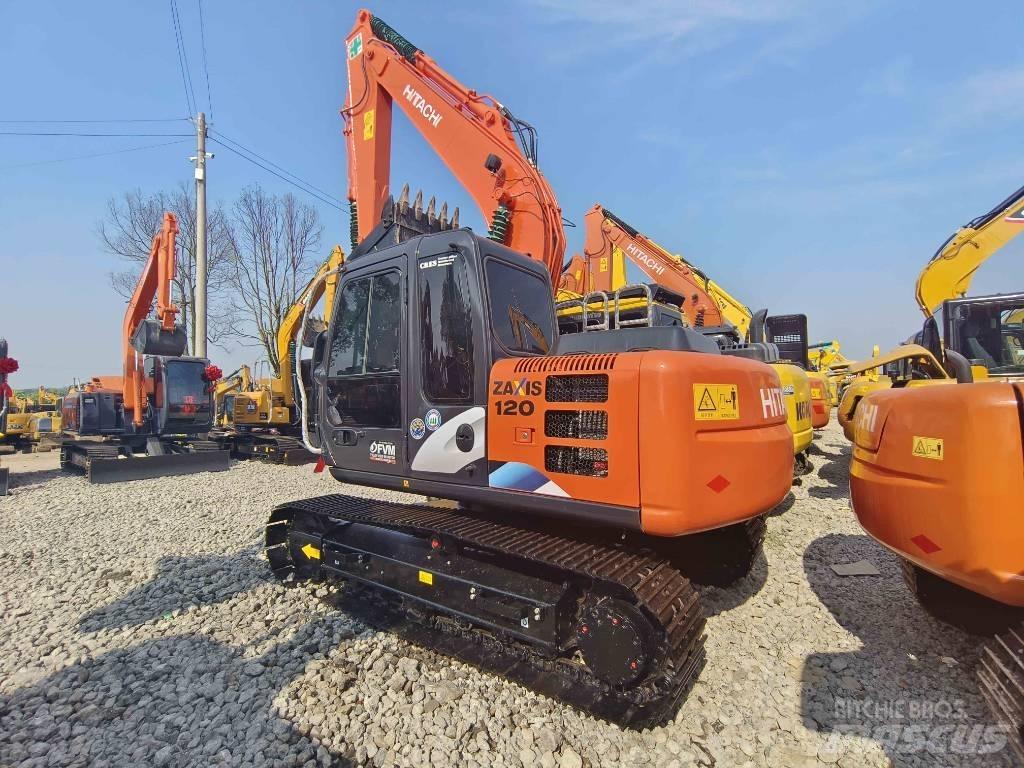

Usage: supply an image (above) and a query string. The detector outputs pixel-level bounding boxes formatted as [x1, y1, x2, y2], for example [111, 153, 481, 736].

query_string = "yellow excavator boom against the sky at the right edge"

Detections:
[914, 186, 1024, 317]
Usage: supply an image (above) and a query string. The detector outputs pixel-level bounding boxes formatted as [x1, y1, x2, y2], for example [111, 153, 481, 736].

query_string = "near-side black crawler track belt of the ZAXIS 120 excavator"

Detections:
[267, 495, 705, 728]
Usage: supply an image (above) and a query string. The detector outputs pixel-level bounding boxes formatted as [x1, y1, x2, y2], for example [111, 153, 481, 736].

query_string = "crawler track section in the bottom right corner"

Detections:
[976, 624, 1024, 762]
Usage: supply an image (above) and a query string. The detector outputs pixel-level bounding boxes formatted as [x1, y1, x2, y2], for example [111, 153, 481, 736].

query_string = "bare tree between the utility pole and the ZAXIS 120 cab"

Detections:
[230, 184, 323, 376]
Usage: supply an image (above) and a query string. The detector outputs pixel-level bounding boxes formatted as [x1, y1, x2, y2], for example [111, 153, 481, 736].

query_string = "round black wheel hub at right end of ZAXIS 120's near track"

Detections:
[575, 598, 654, 686]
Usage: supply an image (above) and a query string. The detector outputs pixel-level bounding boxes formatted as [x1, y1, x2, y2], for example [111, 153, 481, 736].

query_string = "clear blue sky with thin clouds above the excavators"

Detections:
[0, 0, 1024, 386]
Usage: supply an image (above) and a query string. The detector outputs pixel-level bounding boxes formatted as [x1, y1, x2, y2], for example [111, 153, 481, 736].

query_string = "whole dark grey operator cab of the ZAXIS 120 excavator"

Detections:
[313, 229, 557, 485]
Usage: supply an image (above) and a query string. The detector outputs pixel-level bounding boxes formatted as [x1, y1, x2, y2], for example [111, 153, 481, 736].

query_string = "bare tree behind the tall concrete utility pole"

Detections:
[98, 183, 234, 352]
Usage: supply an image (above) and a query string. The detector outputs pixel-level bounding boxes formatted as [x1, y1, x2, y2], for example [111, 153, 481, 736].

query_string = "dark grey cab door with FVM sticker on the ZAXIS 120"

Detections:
[319, 254, 409, 475]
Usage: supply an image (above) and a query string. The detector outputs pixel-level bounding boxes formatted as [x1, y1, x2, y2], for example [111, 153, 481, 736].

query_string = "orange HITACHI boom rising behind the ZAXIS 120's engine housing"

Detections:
[559, 204, 751, 338]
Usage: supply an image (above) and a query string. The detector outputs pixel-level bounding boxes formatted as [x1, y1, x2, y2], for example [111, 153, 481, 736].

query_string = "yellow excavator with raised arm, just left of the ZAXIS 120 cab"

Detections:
[219, 246, 345, 464]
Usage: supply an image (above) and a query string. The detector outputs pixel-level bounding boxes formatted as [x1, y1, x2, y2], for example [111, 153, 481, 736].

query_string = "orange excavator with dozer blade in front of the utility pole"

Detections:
[60, 213, 228, 482]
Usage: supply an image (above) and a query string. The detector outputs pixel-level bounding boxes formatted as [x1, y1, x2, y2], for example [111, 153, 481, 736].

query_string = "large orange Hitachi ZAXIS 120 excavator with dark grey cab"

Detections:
[266, 10, 793, 726]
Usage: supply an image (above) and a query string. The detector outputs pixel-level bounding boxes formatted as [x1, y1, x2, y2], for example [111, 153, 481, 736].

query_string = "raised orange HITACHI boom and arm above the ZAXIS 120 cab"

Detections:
[341, 10, 565, 285]
